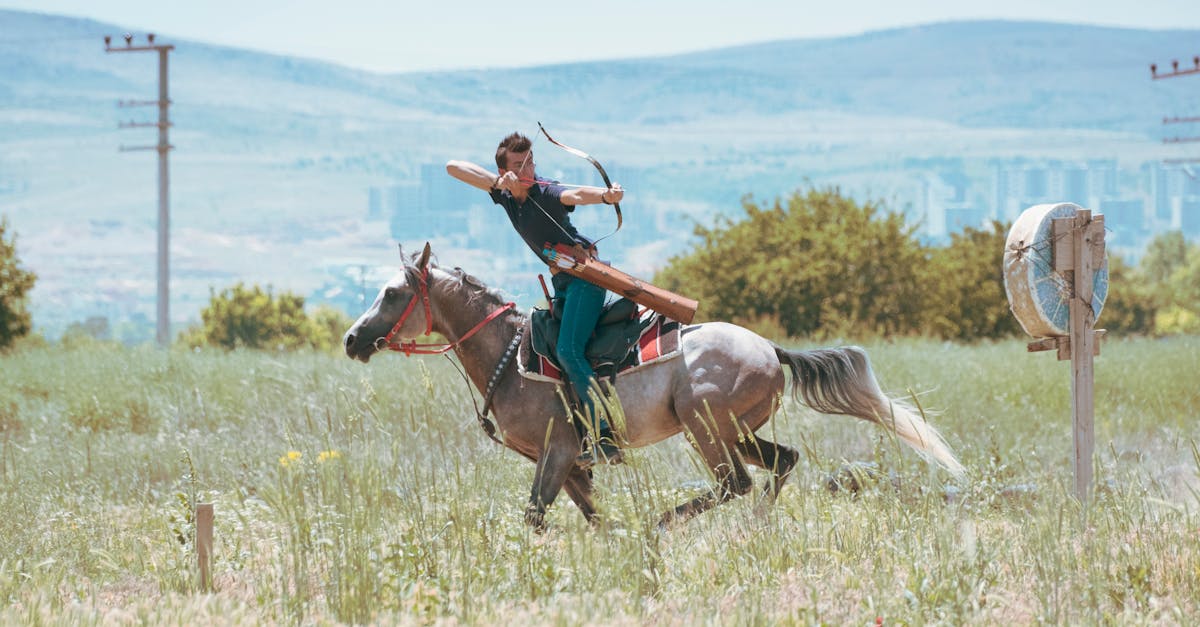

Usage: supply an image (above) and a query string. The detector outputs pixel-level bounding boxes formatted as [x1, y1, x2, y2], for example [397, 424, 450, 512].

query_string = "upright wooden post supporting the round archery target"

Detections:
[1070, 209, 1103, 503]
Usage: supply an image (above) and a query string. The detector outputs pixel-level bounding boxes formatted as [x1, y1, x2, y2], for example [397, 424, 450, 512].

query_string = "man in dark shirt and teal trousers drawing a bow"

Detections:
[446, 132, 624, 467]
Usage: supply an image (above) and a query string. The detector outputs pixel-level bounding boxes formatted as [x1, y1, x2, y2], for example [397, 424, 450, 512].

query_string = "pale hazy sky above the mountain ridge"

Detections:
[0, 0, 1200, 72]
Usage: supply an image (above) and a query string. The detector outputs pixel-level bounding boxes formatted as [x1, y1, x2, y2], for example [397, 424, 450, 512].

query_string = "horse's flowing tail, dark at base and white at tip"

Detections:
[774, 346, 964, 476]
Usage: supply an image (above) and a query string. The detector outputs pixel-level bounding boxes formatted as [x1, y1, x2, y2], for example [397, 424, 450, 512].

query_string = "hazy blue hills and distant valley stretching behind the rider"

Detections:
[0, 10, 1200, 336]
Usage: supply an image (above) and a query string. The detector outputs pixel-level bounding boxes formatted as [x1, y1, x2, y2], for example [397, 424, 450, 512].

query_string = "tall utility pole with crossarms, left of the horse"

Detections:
[104, 32, 175, 347]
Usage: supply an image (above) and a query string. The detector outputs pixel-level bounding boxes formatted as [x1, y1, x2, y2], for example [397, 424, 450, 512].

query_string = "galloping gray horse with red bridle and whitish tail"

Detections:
[344, 244, 962, 529]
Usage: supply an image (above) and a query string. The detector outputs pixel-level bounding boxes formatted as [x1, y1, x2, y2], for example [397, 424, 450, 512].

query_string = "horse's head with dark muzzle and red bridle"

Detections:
[342, 243, 432, 363]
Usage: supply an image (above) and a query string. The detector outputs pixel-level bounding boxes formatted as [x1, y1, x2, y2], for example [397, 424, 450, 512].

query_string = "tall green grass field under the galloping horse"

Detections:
[0, 338, 1200, 625]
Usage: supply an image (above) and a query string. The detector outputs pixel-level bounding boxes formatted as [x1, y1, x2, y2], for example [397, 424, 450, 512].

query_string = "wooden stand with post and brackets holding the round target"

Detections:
[1014, 209, 1105, 503]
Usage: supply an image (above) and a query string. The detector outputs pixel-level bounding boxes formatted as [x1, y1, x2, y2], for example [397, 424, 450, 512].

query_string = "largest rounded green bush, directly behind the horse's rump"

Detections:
[655, 189, 924, 336]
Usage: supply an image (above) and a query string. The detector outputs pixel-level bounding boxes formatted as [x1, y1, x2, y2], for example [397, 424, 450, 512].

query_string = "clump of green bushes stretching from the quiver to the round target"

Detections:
[655, 189, 1019, 340]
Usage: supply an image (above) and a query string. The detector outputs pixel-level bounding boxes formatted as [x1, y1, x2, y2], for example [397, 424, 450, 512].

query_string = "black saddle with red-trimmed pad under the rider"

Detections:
[517, 298, 680, 381]
